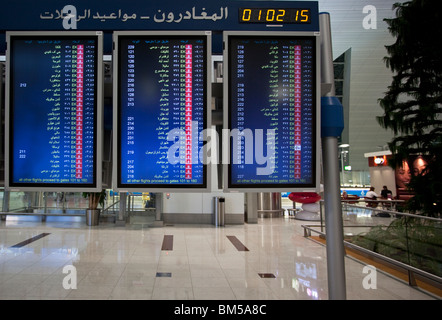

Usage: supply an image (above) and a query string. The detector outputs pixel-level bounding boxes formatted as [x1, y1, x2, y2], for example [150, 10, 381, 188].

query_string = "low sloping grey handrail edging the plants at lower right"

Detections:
[302, 224, 442, 286]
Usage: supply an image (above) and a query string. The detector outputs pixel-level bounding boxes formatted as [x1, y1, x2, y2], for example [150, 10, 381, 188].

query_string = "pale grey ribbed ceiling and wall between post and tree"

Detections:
[318, 0, 404, 171]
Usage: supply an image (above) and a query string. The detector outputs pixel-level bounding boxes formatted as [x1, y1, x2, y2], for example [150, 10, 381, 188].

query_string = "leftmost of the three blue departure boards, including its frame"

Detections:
[7, 32, 102, 191]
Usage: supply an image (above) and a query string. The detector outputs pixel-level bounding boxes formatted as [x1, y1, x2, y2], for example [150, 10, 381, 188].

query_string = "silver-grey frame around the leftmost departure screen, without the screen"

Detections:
[5, 31, 104, 192]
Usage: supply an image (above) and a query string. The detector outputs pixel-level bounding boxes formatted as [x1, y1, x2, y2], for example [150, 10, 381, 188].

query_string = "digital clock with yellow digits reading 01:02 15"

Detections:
[239, 8, 311, 24]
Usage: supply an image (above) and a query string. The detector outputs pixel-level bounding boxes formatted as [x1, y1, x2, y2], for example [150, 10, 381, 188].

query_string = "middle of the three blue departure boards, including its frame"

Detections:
[114, 31, 211, 192]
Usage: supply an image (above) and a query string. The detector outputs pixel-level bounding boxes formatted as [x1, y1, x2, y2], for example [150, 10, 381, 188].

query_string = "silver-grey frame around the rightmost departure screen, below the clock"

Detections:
[223, 31, 321, 192]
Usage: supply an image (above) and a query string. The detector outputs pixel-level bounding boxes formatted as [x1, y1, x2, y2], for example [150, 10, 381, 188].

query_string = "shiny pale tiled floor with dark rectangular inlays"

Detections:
[0, 212, 434, 300]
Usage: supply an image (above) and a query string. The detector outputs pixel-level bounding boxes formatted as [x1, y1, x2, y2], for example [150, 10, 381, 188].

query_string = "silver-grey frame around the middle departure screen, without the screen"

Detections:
[112, 30, 212, 193]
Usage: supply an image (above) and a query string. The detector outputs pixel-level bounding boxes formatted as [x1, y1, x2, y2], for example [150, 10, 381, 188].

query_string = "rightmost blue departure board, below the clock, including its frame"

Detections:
[224, 32, 319, 191]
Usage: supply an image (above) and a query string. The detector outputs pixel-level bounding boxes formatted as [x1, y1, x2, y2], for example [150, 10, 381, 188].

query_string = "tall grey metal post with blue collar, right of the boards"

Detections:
[319, 13, 347, 300]
